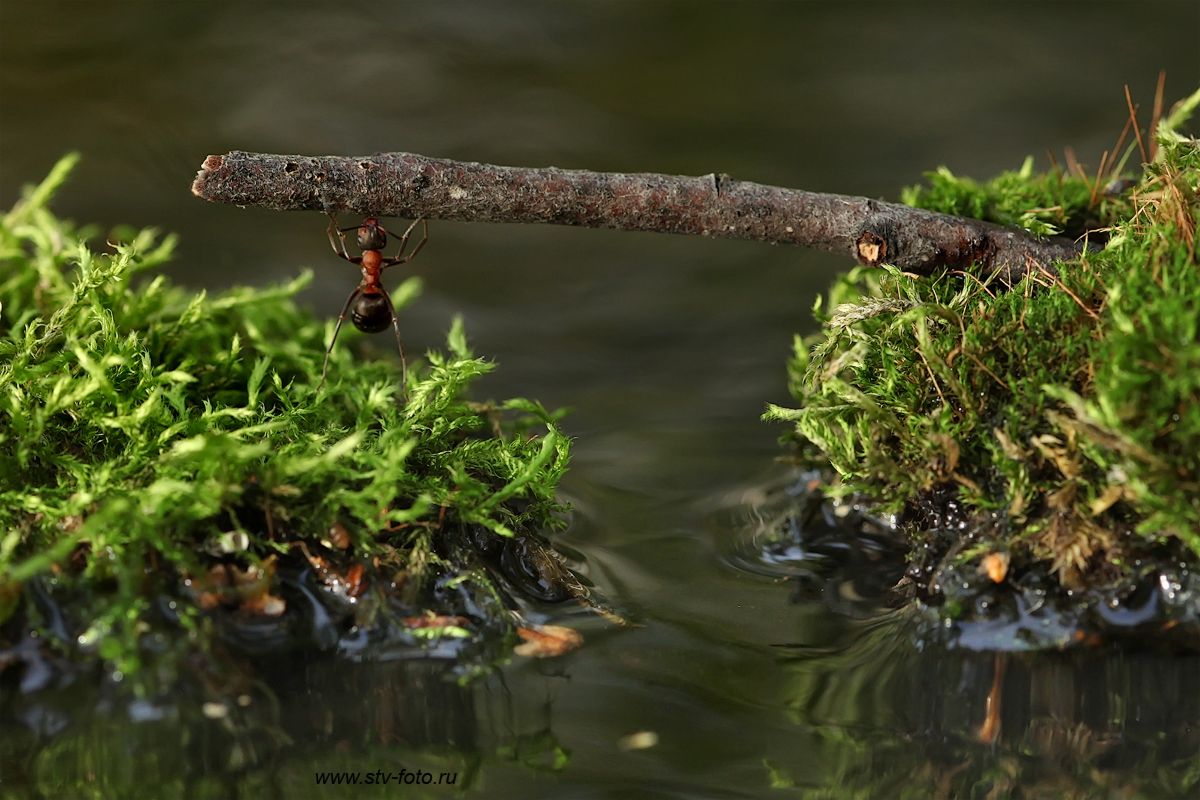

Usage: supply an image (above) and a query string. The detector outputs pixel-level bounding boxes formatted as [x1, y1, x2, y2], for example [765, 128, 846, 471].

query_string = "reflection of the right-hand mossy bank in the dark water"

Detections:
[769, 647, 1200, 796]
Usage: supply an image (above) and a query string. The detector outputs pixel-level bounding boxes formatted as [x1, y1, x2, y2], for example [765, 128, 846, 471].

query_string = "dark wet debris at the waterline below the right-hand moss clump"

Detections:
[726, 473, 1200, 652]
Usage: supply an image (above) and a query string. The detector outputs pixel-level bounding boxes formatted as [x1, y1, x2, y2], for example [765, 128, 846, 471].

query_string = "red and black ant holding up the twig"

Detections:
[317, 213, 430, 395]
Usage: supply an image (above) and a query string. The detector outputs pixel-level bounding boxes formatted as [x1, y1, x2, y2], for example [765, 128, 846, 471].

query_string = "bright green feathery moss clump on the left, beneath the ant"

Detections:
[0, 158, 569, 672]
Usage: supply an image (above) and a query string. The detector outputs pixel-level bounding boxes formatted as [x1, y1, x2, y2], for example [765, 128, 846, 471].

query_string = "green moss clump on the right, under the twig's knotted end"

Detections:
[767, 92, 1200, 587]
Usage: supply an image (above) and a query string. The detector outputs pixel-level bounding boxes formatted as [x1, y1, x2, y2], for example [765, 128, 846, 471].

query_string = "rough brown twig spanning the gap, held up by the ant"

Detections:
[192, 151, 1081, 283]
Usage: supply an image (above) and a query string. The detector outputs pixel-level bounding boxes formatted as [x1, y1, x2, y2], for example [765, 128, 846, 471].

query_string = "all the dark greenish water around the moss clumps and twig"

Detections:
[0, 0, 1200, 798]
